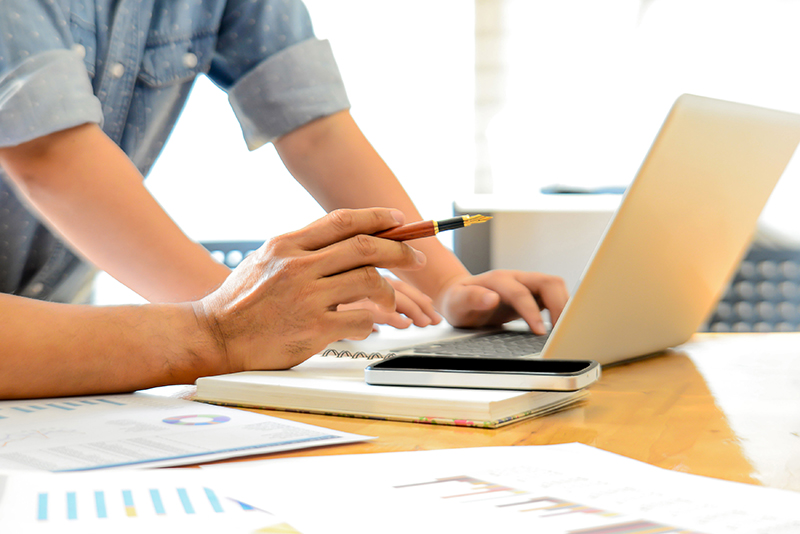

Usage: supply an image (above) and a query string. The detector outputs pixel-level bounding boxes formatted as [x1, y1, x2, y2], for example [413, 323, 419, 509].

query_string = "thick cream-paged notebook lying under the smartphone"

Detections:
[195, 349, 588, 428]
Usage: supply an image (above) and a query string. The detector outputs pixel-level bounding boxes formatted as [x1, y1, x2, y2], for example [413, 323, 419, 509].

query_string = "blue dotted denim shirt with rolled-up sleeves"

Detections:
[0, 0, 349, 300]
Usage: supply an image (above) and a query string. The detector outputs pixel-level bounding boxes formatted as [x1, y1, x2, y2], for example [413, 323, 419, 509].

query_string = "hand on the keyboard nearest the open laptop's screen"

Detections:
[440, 270, 569, 334]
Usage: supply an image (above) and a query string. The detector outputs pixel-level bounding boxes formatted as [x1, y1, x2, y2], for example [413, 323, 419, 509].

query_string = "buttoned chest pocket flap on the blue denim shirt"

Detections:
[139, 33, 216, 87]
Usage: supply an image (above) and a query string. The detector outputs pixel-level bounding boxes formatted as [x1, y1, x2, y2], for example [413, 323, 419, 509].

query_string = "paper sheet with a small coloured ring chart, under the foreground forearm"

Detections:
[0, 393, 371, 471]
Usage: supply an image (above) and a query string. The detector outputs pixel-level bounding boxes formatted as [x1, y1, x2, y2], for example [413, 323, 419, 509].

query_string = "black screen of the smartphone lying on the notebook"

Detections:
[371, 356, 594, 375]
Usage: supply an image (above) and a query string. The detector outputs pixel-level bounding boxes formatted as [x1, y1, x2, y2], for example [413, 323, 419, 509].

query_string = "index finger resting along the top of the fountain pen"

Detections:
[290, 208, 405, 250]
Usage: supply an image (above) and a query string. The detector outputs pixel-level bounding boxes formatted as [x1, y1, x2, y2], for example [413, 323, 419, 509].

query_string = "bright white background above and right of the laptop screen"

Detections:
[488, 0, 800, 243]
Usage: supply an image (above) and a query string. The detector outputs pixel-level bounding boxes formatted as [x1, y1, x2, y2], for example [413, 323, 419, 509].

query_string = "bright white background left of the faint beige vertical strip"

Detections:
[95, 0, 474, 304]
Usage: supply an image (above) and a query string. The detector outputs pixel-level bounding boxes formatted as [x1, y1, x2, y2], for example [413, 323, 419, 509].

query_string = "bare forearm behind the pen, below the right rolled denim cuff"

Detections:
[275, 111, 469, 308]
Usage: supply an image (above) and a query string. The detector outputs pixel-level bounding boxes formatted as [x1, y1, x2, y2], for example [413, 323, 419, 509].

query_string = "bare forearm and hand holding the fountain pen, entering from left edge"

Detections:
[0, 209, 425, 398]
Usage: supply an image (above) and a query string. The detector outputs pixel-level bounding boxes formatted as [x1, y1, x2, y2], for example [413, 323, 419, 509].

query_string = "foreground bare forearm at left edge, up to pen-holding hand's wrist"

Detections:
[0, 295, 222, 398]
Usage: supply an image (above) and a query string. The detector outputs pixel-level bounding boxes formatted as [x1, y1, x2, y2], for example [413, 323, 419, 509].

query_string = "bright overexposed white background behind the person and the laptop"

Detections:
[96, 0, 800, 303]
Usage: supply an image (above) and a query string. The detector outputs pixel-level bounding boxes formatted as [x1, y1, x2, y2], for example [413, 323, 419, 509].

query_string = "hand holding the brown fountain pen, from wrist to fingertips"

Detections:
[194, 208, 426, 372]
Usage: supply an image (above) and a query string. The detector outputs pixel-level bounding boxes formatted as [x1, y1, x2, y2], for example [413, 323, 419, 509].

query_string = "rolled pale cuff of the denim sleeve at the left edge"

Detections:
[0, 50, 103, 147]
